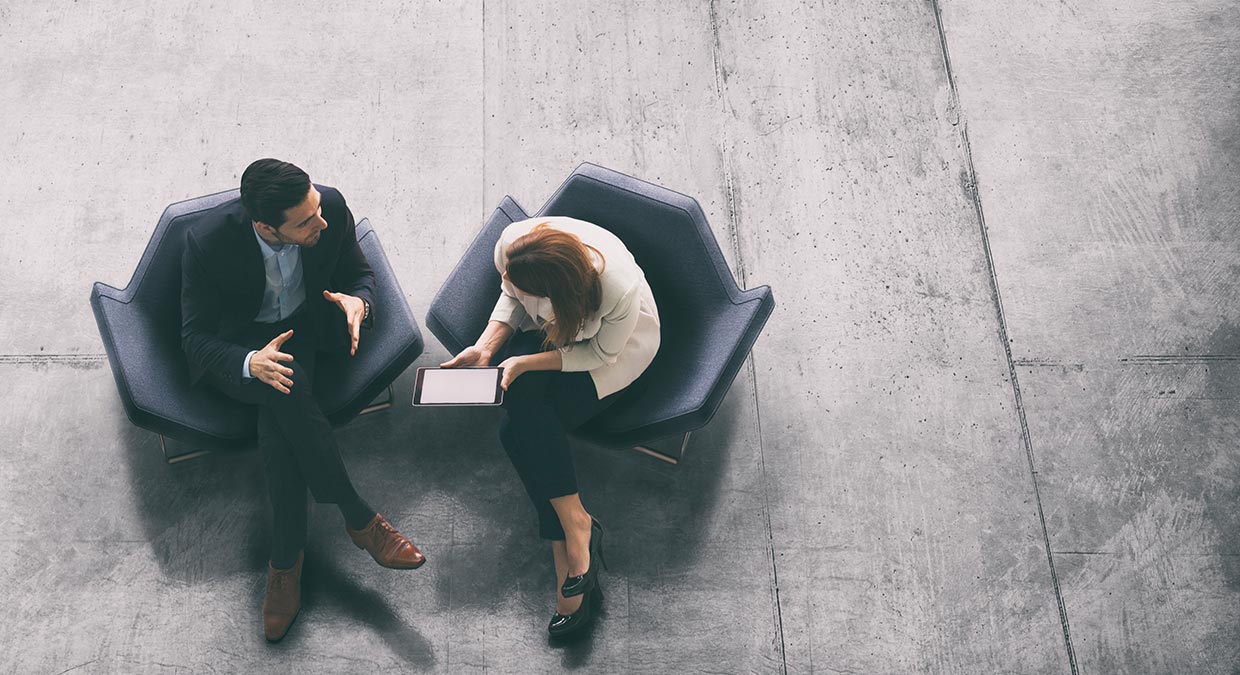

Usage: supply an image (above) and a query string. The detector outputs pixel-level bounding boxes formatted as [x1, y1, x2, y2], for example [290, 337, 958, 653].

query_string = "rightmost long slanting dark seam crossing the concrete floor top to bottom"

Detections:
[930, 0, 1079, 675]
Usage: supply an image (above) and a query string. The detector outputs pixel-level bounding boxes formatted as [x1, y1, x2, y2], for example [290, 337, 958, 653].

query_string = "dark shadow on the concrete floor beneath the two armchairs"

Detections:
[118, 357, 761, 668]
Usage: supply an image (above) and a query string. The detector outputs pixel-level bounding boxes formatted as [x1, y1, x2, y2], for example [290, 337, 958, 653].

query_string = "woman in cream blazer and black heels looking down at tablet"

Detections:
[444, 216, 660, 638]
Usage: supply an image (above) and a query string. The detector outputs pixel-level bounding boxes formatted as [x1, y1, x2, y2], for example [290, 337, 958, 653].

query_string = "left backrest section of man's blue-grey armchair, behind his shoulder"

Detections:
[125, 189, 241, 327]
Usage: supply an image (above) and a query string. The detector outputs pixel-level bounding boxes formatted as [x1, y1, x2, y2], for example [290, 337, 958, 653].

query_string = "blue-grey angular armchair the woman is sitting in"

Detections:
[427, 164, 775, 463]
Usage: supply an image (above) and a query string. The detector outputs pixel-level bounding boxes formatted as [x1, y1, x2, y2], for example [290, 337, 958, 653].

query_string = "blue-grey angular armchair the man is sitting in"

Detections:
[91, 190, 423, 462]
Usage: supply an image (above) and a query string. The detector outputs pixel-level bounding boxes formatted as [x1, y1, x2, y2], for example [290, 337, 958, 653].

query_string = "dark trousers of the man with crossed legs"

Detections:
[207, 305, 357, 563]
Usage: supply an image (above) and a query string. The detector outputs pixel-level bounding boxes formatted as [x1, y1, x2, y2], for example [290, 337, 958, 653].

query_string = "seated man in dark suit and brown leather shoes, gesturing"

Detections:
[181, 159, 425, 641]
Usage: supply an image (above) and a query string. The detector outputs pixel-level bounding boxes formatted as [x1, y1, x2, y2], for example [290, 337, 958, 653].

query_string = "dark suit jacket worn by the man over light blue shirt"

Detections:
[181, 185, 374, 383]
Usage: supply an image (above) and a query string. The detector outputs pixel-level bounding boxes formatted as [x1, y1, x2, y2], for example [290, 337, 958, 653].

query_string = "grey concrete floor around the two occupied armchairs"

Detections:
[0, 0, 1240, 675]
